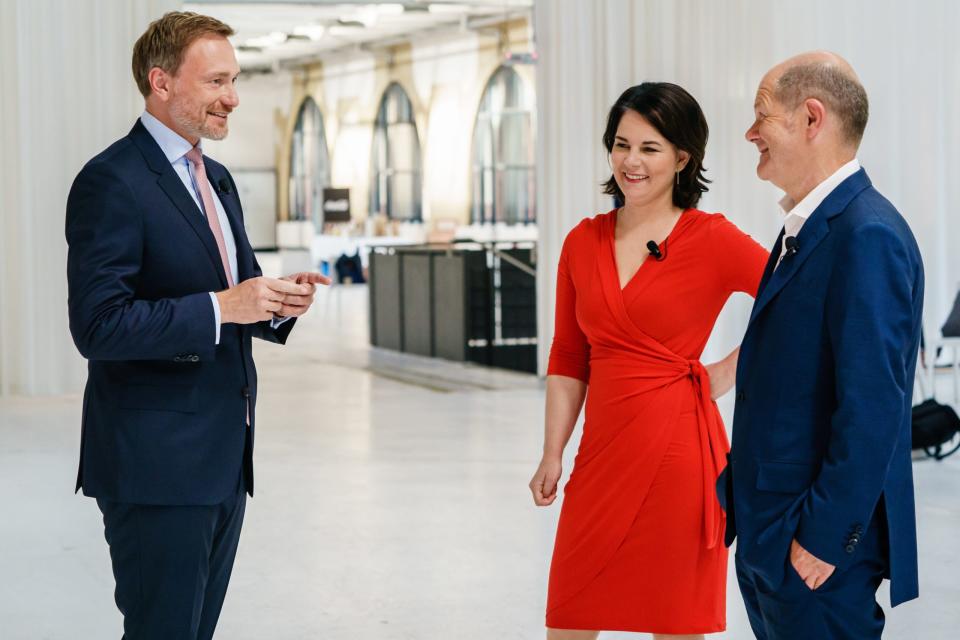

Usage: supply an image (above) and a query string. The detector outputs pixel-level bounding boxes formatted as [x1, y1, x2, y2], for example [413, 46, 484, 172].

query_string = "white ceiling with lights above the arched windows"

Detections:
[183, 0, 533, 70]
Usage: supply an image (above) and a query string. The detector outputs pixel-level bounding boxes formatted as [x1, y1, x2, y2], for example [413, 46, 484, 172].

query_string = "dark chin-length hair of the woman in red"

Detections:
[603, 82, 710, 209]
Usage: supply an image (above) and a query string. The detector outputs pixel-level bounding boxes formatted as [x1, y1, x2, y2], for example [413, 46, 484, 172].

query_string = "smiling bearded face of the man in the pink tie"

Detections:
[152, 36, 240, 144]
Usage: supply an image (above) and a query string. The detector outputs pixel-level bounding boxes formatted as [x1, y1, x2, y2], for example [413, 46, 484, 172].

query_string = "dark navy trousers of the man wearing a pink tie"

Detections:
[97, 483, 247, 640]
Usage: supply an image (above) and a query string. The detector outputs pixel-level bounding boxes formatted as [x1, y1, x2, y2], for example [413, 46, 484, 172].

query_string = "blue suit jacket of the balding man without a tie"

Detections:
[718, 169, 923, 605]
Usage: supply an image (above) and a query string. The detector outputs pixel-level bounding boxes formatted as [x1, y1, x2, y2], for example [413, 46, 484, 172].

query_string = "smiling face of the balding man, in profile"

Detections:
[745, 69, 806, 192]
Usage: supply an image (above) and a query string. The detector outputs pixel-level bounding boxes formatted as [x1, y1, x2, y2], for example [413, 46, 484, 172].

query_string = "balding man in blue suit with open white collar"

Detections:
[718, 52, 923, 640]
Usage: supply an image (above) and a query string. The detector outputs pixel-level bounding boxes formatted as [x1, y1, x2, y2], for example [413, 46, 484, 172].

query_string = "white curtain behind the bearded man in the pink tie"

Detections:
[0, 0, 181, 395]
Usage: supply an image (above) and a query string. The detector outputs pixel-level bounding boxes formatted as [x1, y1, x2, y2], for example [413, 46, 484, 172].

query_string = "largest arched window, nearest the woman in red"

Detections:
[470, 67, 536, 223]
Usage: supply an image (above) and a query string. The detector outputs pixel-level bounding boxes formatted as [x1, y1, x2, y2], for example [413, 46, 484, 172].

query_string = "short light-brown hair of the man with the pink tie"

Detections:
[132, 11, 234, 98]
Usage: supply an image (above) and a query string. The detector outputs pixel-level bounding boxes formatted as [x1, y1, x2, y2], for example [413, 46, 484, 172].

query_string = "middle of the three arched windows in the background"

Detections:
[370, 83, 422, 221]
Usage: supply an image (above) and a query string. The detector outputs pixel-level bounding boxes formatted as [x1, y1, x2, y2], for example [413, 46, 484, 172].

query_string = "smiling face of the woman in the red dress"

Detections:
[610, 109, 689, 205]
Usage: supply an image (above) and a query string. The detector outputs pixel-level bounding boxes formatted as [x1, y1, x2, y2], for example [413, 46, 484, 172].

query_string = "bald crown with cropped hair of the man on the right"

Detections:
[765, 51, 869, 149]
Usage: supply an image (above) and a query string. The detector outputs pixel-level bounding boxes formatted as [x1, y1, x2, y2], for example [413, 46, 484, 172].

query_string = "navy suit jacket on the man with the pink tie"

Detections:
[66, 120, 293, 505]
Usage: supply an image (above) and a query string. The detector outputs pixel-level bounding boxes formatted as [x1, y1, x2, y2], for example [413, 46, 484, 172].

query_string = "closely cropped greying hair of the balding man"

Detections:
[774, 62, 870, 147]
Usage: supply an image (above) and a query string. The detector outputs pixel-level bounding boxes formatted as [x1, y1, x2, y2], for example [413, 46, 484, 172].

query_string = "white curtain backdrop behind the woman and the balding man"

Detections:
[534, 0, 960, 373]
